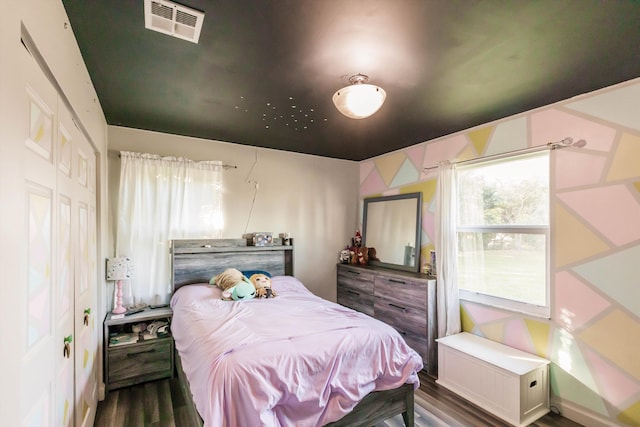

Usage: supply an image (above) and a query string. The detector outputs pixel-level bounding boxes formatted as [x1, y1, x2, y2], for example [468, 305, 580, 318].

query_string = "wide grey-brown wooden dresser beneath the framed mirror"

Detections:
[337, 264, 438, 376]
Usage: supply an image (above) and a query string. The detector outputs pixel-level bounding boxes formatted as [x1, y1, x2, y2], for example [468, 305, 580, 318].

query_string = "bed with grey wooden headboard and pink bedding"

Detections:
[171, 239, 423, 427]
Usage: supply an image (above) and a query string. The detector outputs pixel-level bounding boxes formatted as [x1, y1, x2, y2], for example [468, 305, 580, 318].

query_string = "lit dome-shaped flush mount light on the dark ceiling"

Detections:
[333, 74, 387, 119]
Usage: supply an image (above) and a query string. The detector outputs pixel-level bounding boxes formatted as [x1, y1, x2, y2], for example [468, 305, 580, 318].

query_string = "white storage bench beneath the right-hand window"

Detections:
[436, 332, 549, 426]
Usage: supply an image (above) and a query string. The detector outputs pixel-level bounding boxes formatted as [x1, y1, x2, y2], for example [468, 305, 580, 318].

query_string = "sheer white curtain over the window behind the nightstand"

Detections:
[116, 152, 223, 304]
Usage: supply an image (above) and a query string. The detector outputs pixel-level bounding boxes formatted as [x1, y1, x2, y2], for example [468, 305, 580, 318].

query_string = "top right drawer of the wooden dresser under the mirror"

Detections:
[374, 275, 427, 310]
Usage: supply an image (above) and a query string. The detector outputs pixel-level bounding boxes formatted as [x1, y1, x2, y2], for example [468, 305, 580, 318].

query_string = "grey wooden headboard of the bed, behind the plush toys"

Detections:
[171, 239, 293, 291]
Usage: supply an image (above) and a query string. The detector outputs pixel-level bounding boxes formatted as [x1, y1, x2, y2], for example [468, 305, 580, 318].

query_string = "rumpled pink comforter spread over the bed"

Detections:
[171, 276, 422, 427]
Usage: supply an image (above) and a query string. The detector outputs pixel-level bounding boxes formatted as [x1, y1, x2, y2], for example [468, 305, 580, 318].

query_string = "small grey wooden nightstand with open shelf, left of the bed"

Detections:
[104, 307, 174, 391]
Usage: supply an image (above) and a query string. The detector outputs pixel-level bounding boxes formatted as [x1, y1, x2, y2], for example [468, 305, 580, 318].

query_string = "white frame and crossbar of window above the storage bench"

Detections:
[456, 151, 551, 319]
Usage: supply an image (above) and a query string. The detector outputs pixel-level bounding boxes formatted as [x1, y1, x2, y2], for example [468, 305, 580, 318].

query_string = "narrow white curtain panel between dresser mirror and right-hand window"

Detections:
[435, 162, 461, 337]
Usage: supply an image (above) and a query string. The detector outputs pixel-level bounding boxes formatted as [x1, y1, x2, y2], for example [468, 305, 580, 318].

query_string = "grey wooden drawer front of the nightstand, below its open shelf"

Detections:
[107, 338, 173, 387]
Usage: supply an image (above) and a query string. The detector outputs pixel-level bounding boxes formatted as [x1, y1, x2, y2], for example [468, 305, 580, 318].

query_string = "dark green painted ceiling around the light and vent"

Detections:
[63, 0, 640, 160]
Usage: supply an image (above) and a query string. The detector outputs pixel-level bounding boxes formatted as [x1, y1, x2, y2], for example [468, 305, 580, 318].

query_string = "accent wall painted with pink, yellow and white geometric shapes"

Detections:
[360, 79, 640, 426]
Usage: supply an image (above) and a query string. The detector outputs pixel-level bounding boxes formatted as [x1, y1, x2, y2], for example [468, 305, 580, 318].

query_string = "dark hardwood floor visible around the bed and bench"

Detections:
[94, 372, 580, 427]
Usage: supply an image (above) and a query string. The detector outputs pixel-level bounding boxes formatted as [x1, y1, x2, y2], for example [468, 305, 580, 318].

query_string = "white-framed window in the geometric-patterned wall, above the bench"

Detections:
[457, 151, 550, 317]
